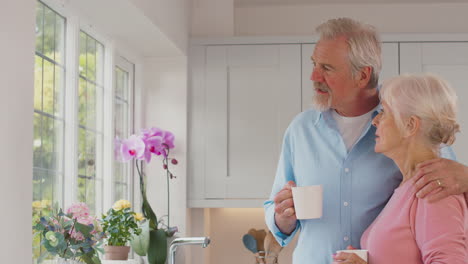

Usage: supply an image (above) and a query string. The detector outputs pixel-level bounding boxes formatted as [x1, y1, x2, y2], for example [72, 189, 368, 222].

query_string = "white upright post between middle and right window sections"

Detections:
[102, 42, 115, 210]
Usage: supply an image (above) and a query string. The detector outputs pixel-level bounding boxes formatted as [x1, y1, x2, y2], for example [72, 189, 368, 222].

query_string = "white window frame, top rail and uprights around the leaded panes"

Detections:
[37, 0, 138, 216]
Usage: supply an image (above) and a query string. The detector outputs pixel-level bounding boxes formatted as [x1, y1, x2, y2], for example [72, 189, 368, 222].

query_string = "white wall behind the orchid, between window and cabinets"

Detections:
[143, 57, 187, 236]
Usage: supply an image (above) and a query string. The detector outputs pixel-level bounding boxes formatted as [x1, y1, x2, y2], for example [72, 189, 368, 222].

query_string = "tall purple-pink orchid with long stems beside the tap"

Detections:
[115, 127, 178, 264]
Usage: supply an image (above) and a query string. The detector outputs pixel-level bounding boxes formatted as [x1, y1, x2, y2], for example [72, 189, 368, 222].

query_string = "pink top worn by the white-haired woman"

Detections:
[361, 180, 468, 264]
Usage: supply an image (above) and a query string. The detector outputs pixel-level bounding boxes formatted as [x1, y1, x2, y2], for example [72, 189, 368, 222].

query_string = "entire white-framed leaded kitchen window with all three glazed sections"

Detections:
[32, 0, 134, 255]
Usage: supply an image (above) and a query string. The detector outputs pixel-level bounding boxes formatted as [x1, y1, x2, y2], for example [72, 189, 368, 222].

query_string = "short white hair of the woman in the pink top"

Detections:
[380, 74, 460, 149]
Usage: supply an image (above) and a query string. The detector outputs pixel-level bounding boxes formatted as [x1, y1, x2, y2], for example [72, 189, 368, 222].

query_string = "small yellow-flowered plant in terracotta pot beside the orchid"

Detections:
[102, 200, 143, 260]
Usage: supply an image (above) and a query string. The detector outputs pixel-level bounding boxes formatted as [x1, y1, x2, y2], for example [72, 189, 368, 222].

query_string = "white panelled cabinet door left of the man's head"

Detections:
[204, 45, 301, 199]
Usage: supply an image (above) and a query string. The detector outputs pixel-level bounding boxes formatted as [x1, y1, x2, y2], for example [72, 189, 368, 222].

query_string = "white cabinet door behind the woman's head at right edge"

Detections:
[400, 42, 468, 164]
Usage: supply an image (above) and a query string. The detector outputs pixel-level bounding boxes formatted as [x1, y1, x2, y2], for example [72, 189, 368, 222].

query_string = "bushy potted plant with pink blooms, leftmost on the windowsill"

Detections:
[33, 203, 104, 264]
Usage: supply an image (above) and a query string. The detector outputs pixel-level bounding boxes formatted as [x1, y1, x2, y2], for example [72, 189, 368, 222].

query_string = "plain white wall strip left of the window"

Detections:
[0, 0, 36, 263]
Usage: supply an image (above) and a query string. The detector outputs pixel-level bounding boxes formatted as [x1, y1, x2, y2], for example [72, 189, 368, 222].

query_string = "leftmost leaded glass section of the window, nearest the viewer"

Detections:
[33, 2, 66, 256]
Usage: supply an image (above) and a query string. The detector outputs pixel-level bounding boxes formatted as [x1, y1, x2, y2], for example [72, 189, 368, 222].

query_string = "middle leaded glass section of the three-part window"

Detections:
[77, 31, 104, 214]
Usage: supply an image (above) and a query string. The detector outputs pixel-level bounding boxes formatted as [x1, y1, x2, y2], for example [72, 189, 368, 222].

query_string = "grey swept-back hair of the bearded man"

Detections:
[315, 18, 382, 88]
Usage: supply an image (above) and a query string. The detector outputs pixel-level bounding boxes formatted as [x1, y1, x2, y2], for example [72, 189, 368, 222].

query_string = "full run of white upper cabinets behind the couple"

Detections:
[188, 35, 468, 207]
